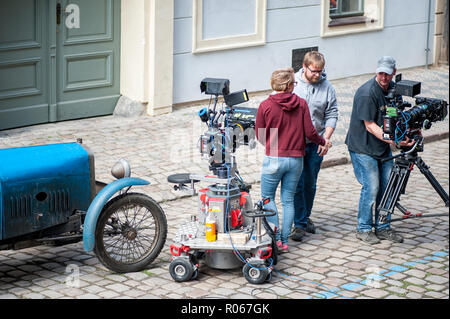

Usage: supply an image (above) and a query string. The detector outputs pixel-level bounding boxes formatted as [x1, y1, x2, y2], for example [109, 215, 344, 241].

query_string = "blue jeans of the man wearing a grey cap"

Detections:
[350, 152, 394, 232]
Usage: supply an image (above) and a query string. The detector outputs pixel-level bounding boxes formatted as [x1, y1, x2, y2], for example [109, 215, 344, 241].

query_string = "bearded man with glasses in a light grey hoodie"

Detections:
[291, 51, 338, 241]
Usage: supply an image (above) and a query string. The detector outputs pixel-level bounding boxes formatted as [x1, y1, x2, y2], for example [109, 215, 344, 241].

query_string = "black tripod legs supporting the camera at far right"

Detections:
[378, 139, 449, 224]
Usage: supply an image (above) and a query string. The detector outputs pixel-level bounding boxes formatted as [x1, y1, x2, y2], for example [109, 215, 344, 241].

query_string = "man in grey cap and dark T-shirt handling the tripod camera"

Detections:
[345, 56, 414, 244]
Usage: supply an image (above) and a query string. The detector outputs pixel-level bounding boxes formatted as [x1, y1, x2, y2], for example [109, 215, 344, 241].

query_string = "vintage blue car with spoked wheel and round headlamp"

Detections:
[0, 140, 167, 273]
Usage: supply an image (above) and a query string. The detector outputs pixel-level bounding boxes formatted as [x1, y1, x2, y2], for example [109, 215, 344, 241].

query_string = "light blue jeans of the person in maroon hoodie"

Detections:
[261, 155, 303, 244]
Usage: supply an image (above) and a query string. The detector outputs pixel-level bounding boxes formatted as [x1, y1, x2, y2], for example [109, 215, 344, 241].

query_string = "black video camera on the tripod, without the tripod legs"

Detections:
[383, 74, 448, 151]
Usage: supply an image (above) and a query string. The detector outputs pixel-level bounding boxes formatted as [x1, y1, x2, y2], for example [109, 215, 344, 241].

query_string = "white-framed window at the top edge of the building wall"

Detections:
[321, 0, 384, 37]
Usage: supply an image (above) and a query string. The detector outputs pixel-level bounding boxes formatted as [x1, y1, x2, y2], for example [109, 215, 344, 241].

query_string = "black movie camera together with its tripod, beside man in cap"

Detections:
[378, 74, 449, 223]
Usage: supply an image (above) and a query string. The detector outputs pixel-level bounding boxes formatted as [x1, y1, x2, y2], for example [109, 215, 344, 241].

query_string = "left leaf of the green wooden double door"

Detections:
[0, 0, 48, 129]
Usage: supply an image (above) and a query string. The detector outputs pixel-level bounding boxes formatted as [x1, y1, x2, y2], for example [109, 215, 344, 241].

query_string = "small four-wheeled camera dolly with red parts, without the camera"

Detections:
[168, 173, 277, 284]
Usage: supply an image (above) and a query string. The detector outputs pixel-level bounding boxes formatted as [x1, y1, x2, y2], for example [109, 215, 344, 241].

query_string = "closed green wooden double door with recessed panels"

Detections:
[0, 0, 120, 129]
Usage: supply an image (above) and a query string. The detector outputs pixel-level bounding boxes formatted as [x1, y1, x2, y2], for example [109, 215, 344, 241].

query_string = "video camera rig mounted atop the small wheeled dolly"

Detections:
[198, 78, 257, 178]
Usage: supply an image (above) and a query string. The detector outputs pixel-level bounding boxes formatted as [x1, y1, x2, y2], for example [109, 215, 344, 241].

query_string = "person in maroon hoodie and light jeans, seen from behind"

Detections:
[255, 68, 331, 251]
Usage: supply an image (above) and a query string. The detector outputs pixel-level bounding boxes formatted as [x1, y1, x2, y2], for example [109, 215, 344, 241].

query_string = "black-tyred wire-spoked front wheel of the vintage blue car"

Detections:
[95, 193, 167, 273]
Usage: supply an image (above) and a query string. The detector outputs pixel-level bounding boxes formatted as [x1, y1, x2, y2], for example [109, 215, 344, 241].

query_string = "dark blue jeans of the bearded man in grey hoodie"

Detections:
[294, 143, 323, 229]
